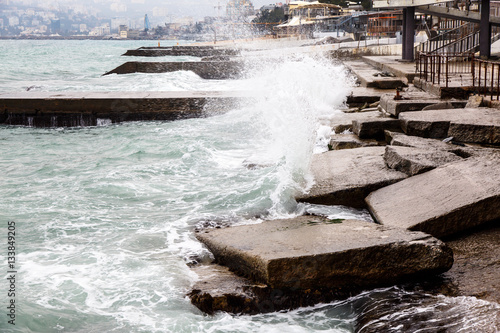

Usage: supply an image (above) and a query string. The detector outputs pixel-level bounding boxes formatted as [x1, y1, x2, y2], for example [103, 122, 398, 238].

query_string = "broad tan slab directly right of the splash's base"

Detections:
[296, 147, 408, 207]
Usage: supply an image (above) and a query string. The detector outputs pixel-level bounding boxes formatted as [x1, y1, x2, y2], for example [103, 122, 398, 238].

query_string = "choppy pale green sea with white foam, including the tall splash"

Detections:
[0, 40, 500, 333]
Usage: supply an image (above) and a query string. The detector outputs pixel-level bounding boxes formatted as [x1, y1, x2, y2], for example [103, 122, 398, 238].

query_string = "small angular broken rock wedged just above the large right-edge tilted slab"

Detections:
[384, 146, 462, 176]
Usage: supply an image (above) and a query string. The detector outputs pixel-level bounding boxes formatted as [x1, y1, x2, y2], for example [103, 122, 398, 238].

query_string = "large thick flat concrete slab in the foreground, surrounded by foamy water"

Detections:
[196, 216, 453, 290]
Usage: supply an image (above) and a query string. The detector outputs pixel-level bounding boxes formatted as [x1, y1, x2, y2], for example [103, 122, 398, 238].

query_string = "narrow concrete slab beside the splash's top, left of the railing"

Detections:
[343, 60, 408, 89]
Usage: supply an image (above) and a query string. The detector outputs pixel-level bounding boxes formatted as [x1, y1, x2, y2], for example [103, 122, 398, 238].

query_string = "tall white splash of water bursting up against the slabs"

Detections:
[231, 55, 353, 215]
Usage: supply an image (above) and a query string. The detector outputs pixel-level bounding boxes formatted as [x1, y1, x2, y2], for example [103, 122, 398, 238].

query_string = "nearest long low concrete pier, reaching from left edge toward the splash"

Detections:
[0, 91, 245, 127]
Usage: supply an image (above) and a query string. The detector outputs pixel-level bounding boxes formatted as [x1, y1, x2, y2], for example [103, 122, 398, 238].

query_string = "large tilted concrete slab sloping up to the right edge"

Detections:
[366, 154, 500, 237]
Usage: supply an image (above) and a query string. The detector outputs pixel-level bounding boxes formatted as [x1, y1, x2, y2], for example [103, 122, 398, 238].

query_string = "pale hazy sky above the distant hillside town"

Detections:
[0, 0, 279, 21]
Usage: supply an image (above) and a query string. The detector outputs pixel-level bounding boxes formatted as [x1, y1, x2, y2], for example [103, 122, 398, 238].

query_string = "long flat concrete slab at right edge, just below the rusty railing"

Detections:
[399, 108, 500, 144]
